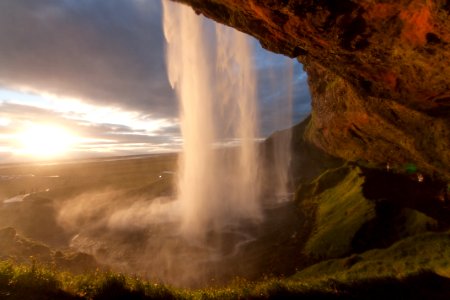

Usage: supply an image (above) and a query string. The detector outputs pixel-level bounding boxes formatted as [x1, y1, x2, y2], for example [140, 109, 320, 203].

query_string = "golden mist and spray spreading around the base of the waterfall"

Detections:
[59, 176, 302, 287]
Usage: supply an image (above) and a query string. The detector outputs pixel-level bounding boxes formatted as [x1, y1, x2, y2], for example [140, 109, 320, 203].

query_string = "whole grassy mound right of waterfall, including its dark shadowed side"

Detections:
[296, 157, 449, 262]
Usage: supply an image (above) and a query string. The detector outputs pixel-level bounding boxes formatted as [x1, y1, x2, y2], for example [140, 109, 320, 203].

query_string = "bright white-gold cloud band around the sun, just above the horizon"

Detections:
[0, 102, 180, 162]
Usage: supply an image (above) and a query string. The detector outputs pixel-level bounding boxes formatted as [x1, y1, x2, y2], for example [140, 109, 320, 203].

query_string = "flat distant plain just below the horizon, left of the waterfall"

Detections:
[0, 154, 177, 200]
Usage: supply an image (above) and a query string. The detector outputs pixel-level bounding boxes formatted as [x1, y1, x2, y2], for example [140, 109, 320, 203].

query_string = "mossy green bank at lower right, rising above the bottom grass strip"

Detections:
[295, 232, 450, 280]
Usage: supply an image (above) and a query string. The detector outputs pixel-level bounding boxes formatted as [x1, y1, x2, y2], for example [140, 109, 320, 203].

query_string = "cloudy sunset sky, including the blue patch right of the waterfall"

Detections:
[0, 0, 310, 163]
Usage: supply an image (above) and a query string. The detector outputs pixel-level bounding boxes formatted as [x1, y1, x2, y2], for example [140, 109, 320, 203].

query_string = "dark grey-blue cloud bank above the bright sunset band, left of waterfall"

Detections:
[0, 0, 178, 117]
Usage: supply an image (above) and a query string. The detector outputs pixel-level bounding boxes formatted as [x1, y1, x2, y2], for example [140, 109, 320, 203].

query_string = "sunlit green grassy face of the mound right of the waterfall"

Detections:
[304, 167, 375, 259]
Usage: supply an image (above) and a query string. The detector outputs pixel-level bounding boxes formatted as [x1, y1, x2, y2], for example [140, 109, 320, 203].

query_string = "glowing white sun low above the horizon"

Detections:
[16, 124, 75, 158]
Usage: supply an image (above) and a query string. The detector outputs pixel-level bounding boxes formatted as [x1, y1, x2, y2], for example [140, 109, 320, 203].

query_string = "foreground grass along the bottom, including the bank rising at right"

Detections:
[0, 231, 450, 300]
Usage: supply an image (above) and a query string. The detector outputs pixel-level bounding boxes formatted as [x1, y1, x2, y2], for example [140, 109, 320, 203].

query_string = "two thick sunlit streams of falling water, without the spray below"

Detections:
[163, 1, 262, 240]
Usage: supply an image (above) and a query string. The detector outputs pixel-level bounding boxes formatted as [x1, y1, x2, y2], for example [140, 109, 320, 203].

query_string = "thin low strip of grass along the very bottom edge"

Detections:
[0, 261, 450, 300]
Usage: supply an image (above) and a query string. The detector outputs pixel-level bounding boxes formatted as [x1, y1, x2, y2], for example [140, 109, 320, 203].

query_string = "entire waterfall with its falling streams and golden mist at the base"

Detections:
[60, 1, 300, 287]
